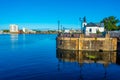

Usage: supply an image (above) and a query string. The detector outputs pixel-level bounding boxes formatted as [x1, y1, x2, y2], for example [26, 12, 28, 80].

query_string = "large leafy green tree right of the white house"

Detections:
[101, 16, 119, 31]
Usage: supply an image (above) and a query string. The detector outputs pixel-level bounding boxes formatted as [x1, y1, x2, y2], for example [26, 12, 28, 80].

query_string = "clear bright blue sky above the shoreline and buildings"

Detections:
[0, 0, 120, 29]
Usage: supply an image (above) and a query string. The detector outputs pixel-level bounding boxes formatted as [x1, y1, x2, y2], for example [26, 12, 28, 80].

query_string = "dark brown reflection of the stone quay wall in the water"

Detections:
[56, 50, 116, 66]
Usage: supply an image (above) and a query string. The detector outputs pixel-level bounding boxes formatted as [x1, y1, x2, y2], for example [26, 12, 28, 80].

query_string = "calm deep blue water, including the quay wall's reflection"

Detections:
[0, 34, 120, 80]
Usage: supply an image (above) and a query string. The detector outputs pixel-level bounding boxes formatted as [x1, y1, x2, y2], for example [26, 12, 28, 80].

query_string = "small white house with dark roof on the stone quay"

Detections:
[83, 22, 105, 35]
